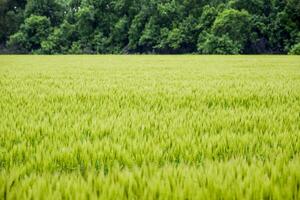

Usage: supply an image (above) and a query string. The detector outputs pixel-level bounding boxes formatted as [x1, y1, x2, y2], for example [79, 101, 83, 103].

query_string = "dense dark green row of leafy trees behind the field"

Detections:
[0, 0, 300, 54]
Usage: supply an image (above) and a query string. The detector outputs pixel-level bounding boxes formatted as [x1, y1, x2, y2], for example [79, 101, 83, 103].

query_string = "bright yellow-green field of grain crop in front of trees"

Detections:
[0, 55, 300, 200]
